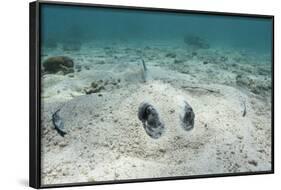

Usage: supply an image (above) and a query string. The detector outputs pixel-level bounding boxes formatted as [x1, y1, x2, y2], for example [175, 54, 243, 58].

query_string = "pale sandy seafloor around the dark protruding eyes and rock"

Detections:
[41, 42, 271, 184]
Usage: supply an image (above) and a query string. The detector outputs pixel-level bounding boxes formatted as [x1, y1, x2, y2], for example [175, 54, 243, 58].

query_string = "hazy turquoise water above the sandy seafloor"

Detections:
[41, 4, 272, 53]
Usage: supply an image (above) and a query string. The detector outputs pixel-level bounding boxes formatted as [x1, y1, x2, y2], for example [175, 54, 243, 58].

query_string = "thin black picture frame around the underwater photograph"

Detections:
[29, 1, 274, 188]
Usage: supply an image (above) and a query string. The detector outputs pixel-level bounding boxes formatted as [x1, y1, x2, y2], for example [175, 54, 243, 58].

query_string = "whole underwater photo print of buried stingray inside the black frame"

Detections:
[40, 4, 273, 185]
